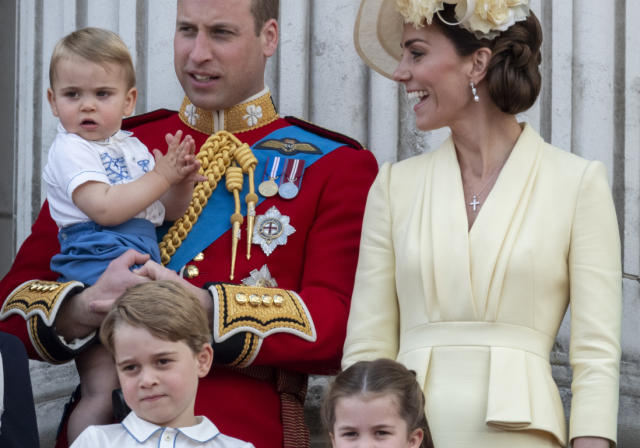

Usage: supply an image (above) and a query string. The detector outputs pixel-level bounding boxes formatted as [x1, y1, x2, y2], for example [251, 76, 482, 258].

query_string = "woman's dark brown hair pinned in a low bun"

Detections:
[433, 4, 542, 114]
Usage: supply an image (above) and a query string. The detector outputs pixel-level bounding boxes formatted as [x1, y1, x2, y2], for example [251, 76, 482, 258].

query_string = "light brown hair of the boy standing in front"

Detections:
[100, 281, 211, 354]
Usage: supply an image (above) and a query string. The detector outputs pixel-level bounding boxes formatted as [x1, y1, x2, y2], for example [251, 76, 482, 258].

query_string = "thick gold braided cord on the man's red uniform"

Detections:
[159, 131, 258, 265]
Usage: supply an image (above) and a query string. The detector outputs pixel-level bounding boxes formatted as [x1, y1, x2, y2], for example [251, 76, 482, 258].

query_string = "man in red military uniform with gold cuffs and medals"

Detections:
[0, 0, 377, 448]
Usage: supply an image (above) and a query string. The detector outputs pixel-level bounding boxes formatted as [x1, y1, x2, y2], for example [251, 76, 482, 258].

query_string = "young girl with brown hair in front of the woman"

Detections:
[322, 359, 433, 448]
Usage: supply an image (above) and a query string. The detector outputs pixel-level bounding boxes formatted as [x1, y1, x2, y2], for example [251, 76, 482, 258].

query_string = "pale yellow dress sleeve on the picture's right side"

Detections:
[569, 162, 622, 443]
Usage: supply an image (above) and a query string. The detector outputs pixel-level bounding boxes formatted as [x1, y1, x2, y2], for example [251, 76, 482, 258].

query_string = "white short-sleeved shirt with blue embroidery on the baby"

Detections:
[42, 123, 164, 228]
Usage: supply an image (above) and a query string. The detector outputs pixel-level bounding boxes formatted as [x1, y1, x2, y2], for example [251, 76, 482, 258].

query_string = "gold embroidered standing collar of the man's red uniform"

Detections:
[180, 87, 278, 134]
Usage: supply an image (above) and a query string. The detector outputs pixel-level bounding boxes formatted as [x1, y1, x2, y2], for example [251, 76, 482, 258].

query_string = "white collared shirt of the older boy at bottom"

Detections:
[71, 412, 254, 448]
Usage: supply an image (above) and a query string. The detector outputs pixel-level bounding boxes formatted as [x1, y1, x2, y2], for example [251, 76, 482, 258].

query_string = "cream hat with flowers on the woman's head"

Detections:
[354, 0, 529, 78]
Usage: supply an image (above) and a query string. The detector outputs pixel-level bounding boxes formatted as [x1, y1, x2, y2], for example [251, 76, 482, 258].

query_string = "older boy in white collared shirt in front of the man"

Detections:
[71, 281, 253, 448]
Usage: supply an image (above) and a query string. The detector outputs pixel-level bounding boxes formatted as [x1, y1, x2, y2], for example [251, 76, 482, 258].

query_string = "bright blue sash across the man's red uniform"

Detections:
[165, 126, 344, 271]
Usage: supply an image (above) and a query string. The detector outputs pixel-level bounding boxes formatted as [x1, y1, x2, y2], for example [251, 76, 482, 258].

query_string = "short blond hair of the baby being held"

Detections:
[49, 27, 136, 89]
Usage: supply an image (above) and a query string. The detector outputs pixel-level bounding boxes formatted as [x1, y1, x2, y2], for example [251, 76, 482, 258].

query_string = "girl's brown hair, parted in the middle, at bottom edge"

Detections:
[321, 359, 433, 448]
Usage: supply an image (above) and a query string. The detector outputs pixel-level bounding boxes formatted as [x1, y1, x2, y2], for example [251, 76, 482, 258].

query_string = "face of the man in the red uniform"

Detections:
[173, 0, 278, 110]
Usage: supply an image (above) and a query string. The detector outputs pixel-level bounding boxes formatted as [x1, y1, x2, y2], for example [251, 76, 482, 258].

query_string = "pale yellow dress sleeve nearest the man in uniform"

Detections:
[342, 164, 399, 368]
